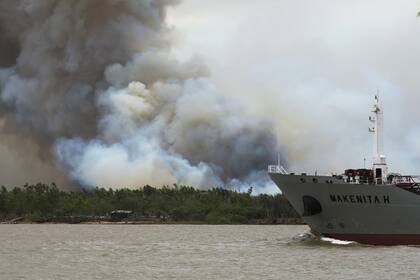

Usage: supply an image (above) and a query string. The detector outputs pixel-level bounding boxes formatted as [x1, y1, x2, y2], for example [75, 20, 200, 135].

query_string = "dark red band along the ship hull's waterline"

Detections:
[323, 233, 420, 245]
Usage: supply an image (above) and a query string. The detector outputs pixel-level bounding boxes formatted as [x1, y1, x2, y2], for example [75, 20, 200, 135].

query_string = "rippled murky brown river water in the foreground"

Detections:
[0, 225, 420, 279]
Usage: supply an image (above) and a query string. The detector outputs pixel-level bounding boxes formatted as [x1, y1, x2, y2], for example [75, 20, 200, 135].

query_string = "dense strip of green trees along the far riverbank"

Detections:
[0, 184, 299, 223]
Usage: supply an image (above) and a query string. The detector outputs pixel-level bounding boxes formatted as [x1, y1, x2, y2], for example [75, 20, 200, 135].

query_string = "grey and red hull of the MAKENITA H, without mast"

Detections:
[270, 173, 420, 245]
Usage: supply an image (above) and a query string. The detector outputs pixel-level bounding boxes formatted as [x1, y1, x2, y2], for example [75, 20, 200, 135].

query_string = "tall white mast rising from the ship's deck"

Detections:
[369, 94, 388, 184]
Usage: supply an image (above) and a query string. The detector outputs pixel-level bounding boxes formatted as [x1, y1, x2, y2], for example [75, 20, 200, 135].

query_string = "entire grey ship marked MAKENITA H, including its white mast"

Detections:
[268, 95, 420, 245]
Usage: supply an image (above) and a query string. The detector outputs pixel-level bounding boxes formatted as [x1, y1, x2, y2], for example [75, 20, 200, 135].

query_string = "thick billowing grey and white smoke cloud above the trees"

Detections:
[0, 0, 279, 190]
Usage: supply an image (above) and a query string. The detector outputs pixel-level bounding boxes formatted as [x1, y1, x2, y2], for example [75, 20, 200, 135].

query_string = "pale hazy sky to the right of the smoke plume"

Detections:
[168, 0, 420, 173]
